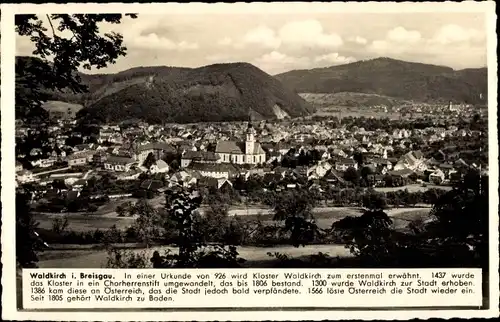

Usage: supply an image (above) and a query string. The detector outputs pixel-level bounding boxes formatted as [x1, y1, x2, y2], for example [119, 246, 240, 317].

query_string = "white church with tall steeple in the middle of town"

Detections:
[215, 123, 266, 164]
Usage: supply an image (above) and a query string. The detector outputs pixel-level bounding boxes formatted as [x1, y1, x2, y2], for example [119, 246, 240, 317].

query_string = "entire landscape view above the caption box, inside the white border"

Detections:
[13, 13, 490, 268]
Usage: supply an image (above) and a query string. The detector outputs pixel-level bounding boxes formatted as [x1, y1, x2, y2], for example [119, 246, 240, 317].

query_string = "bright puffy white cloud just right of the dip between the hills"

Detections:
[278, 19, 343, 48]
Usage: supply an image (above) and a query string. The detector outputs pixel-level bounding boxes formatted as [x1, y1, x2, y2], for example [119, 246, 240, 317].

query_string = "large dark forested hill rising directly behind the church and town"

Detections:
[37, 58, 314, 123]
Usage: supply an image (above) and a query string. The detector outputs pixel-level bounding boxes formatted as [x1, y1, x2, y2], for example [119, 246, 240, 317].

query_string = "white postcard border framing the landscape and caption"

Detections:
[1, 1, 499, 321]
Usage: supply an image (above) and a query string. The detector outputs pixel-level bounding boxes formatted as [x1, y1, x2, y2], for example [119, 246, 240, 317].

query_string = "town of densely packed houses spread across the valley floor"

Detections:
[16, 103, 488, 224]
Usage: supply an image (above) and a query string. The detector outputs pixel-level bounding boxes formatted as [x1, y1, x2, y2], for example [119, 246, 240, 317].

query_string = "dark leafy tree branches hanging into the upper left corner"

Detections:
[15, 14, 137, 121]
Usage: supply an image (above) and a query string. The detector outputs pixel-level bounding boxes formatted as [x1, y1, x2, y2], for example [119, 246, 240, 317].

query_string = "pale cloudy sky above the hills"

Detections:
[16, 11, 487, 75]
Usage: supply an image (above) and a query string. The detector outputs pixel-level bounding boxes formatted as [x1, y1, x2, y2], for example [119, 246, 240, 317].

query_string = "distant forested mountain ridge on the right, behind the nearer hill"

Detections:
[275, 58, 488, 103]
